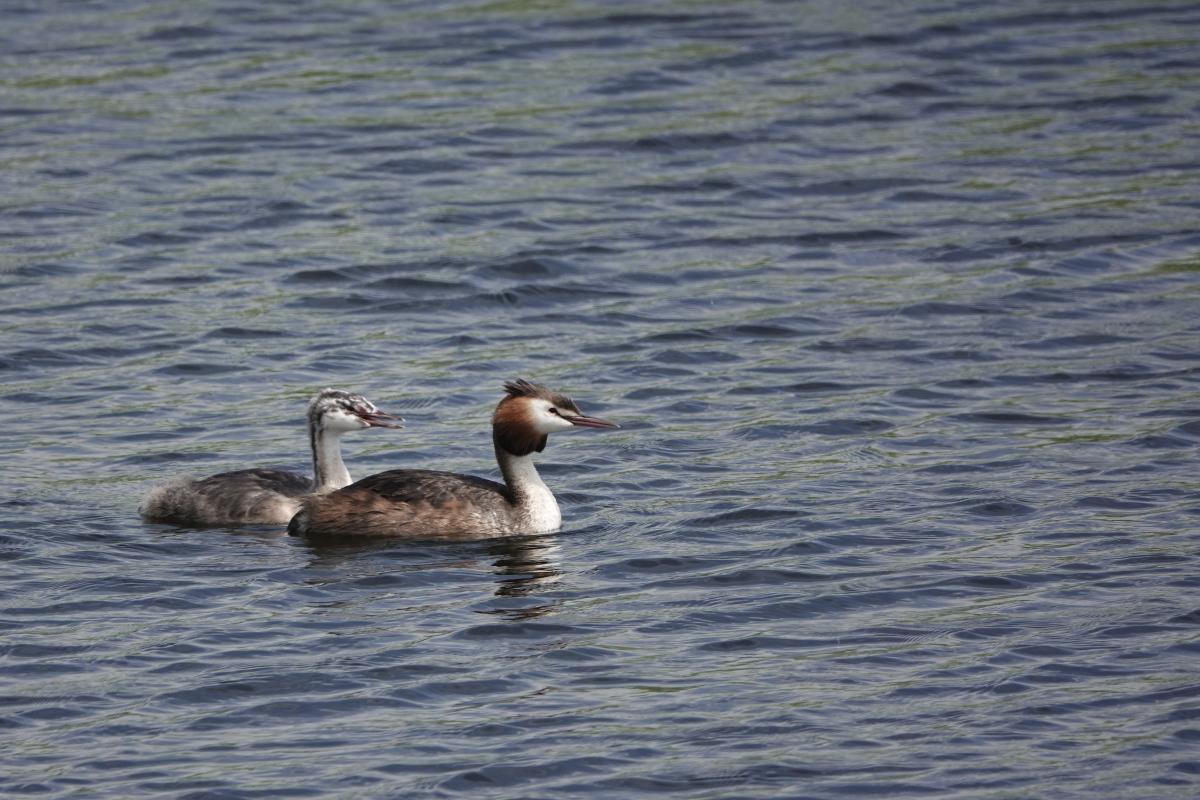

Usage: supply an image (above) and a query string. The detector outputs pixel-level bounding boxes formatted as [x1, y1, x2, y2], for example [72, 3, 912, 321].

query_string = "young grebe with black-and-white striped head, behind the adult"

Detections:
[138, 389, 403, 525]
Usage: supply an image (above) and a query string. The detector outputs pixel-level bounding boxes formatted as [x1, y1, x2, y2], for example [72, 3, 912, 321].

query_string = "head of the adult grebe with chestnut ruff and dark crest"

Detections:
[492, 378, 620, 456]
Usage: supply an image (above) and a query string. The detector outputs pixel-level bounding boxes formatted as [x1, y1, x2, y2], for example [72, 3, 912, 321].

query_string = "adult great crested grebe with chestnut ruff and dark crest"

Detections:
[288, 380, 618, 539]
